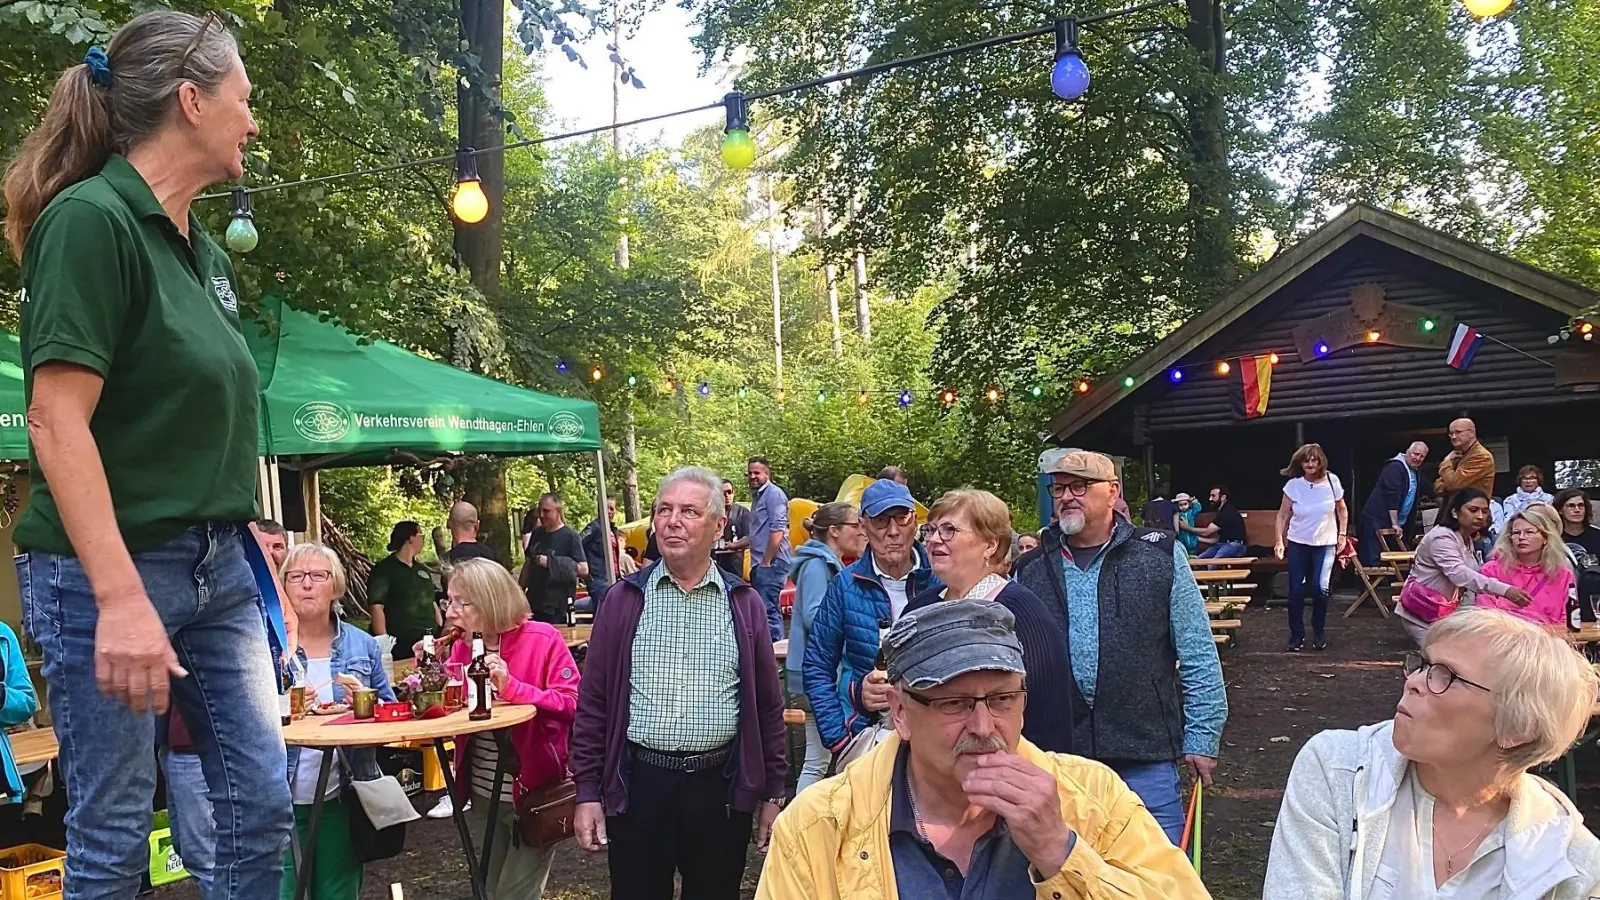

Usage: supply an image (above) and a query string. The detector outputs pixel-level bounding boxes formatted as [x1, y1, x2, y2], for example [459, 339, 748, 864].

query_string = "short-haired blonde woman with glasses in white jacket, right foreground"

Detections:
[1262, 609, 1600, 900]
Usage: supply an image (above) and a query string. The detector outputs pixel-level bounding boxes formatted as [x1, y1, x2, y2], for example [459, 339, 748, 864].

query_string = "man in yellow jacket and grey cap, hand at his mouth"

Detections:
[755, 601, 1210, 900]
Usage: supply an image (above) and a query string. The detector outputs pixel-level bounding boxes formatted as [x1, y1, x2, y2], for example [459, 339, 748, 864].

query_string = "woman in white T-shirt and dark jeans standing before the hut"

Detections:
[1272, 444, 1350, 653]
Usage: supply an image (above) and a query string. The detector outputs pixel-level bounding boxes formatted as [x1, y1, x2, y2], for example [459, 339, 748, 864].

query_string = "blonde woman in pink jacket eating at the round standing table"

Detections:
[432, 559, 578, 900]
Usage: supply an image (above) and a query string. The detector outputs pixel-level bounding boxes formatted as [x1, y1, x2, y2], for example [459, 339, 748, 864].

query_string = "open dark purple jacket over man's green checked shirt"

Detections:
[568, 562, 789, 815]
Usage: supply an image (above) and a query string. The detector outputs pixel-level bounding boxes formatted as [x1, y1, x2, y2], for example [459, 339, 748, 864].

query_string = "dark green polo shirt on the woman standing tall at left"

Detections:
[16, 155, 259, 556]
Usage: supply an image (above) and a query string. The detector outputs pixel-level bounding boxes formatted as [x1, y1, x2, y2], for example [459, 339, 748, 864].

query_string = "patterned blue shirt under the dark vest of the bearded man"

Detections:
[1061, 543, 1227, 757]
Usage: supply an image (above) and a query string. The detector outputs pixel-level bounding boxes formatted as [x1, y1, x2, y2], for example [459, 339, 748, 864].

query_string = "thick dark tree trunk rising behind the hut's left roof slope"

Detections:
[1184, 0, 1238, 304]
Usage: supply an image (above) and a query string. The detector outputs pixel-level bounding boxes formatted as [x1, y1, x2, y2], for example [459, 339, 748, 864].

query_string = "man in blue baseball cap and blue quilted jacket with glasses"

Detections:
[802, 479, 939, 754]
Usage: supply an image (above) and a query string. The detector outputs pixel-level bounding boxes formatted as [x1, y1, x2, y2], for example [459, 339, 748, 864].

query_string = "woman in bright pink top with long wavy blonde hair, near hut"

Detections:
[1478, 503, 1574, 625]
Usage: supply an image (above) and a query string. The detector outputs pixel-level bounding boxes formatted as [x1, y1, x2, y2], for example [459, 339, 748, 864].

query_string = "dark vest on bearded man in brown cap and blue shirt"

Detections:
[1016, 522, 1184, 762]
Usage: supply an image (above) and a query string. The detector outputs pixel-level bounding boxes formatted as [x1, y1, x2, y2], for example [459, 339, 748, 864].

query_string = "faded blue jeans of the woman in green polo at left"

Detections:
[16, 522, 293, 900]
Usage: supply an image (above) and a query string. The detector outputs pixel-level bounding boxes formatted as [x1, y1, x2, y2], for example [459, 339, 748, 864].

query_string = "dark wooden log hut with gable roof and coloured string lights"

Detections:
[1048, 205, 1600, 517]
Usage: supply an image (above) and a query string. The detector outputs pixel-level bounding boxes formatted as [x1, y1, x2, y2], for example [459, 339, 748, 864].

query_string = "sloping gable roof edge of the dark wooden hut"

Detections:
[1045, 203, 1600, 442]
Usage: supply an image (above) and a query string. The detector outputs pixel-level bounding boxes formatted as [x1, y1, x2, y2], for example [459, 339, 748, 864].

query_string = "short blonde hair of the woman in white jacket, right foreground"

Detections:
[1422, 607, 1600, 772]
